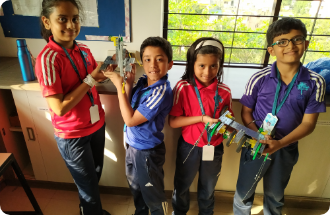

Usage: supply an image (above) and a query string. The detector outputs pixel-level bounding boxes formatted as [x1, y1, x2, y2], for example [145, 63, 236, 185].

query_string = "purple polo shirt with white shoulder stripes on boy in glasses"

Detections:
[240, 62, 326, 139]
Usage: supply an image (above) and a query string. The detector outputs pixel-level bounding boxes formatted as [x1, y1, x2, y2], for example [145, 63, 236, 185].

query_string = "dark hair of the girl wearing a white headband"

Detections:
[181, 37, 225, 84]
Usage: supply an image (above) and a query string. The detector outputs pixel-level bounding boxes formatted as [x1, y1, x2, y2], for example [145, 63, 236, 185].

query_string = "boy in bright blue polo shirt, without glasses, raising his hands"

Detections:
[104, 37, 173, 215]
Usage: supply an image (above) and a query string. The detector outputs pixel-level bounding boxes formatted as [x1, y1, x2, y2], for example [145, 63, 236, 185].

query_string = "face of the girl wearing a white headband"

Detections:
[194, 54, 220, 87]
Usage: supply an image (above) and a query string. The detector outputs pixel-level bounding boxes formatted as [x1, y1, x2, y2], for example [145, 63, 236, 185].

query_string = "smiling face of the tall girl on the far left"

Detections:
[42, 2, 80, 49]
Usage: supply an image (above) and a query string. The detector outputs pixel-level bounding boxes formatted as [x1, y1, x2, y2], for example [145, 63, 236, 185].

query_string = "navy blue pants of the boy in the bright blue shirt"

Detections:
[126, 142, 167, 215]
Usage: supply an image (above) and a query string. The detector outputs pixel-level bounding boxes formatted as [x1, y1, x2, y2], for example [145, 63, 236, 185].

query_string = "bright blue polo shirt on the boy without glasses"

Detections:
[125, 74, 173, 150]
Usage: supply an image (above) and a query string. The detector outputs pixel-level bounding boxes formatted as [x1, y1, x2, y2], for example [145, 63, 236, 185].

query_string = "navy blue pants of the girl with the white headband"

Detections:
[172, 136, 223, 215]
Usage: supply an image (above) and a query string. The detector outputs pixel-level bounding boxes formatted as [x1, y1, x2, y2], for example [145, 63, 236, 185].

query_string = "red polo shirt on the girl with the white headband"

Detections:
[170, 79, 233, 147]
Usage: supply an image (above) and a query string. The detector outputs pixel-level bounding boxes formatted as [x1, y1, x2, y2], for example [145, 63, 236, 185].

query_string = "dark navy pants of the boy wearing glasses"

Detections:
[233, 144, 299, 215]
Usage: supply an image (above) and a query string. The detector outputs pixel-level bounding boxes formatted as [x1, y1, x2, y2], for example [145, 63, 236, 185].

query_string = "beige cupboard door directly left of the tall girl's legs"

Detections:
[26, 91, 73, 183]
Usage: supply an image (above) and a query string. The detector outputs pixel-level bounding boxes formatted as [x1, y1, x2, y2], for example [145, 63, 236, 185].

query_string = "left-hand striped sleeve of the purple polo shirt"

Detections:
[240, 75, 261, 109]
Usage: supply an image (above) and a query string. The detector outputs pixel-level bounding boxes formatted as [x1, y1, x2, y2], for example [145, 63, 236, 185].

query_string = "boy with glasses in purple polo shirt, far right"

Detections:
[233, 18, 326, 215]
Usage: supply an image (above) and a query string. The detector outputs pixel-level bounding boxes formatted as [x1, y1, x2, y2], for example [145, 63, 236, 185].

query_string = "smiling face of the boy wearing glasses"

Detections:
[267, 29, 309, 64]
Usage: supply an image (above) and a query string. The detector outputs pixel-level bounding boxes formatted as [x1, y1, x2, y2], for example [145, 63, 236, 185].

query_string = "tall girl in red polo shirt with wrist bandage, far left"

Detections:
[35, 0, 109, 215]
